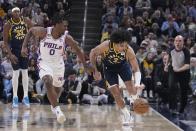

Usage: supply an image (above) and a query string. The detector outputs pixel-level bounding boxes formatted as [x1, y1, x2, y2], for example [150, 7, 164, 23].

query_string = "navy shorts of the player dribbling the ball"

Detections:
[104, 63, 132, 86]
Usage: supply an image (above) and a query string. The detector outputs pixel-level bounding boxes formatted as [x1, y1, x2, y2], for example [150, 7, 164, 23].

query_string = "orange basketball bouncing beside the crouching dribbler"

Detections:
[133, 98, 149, 114]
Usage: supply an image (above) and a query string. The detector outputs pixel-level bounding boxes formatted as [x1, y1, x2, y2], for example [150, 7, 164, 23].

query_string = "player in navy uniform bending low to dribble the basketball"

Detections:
[90, 30, 142, 125]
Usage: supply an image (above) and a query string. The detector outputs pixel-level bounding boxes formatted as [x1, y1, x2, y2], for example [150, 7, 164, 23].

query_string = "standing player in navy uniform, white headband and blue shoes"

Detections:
[3, 7, 33, 108]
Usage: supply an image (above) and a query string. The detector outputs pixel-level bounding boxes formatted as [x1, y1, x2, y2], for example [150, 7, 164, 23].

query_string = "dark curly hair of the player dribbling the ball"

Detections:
[110, 29, 131, 44]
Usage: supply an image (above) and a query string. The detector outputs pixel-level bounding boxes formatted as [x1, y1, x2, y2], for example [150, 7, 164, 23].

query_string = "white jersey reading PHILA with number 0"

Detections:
[38, 27, 67, 66]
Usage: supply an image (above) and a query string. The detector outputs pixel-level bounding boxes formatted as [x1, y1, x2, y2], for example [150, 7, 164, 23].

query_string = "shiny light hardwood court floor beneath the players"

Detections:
[0, 105, 183, 131]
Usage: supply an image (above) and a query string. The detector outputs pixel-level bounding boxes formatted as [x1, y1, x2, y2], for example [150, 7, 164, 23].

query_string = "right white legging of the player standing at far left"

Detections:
[22, 69, 29, 97]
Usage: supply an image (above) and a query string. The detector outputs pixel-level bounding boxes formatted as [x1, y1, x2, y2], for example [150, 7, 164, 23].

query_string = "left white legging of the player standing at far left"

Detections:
[12, 70, 19, 97]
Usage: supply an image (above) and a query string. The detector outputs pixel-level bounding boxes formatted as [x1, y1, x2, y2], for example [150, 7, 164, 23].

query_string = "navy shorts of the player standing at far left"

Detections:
[12, 50, 28, 70]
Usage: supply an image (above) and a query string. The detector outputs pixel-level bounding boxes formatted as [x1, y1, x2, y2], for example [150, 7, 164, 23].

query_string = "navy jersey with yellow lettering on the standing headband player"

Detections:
[8, 18, 27, 50]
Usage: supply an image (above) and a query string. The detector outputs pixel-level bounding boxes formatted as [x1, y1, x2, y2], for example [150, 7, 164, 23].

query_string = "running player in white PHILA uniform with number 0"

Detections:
[21, 14, 85, 124]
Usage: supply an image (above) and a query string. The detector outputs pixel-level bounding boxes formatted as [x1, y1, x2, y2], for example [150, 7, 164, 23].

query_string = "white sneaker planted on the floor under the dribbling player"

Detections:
[121, 108, 133, 126]
